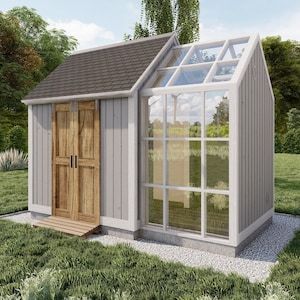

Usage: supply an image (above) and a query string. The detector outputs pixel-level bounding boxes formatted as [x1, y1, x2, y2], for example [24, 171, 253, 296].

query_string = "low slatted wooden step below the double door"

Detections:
[33, 216, 99, 237]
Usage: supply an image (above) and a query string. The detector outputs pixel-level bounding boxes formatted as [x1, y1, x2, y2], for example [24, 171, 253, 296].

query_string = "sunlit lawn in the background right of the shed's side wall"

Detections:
[275, 153, 300, 215]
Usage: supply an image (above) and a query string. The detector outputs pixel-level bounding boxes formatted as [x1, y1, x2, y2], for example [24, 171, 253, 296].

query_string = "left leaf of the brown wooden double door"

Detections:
[52, 103, 74, 218]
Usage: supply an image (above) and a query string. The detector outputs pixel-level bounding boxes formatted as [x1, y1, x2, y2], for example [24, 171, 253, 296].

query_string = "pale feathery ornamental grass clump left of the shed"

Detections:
[0, 149, 28, 171]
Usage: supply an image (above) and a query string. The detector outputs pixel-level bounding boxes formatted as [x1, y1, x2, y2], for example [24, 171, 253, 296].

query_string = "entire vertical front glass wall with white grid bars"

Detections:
[144, 91, 229, 237]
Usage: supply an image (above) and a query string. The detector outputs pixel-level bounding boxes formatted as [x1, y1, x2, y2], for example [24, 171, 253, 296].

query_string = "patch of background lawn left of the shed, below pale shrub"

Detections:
[0, 170, 28, 215]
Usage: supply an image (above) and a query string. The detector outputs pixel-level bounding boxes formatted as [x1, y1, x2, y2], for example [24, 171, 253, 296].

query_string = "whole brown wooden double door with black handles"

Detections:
[52, 101, 100, 224]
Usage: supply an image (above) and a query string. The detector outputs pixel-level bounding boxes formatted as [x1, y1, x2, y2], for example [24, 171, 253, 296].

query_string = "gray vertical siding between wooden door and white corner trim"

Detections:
[100, 98, 128, 220]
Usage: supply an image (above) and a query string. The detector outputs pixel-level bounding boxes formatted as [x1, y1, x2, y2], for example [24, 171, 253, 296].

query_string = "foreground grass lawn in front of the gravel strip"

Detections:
[0, 221, 300, 299]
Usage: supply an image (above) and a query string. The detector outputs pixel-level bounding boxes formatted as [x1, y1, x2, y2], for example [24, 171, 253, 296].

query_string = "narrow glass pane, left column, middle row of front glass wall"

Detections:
[146, 141, 163, 184]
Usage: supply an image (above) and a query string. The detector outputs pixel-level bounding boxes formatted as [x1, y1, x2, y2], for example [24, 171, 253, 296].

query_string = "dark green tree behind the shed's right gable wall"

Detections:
[262, 36, 300, 133]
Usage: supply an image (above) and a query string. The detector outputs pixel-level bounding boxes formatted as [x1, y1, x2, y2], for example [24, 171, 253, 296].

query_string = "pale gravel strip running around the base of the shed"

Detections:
[3, 213, 300, 282]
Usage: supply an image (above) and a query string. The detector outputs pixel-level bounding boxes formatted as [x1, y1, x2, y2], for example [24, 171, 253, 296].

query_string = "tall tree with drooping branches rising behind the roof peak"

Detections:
[125, 0, 200, 44]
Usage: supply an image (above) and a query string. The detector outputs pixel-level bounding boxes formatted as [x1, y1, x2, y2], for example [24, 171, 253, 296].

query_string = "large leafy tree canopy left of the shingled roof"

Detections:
[0, 7, 77, 111]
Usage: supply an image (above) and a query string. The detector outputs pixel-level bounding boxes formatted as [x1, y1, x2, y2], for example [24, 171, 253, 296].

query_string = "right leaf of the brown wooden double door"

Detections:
[73, 101, 100, 224]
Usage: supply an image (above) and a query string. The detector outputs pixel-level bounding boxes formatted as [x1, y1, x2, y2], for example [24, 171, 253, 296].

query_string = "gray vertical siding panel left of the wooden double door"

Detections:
[32, 104, 52, 207]
